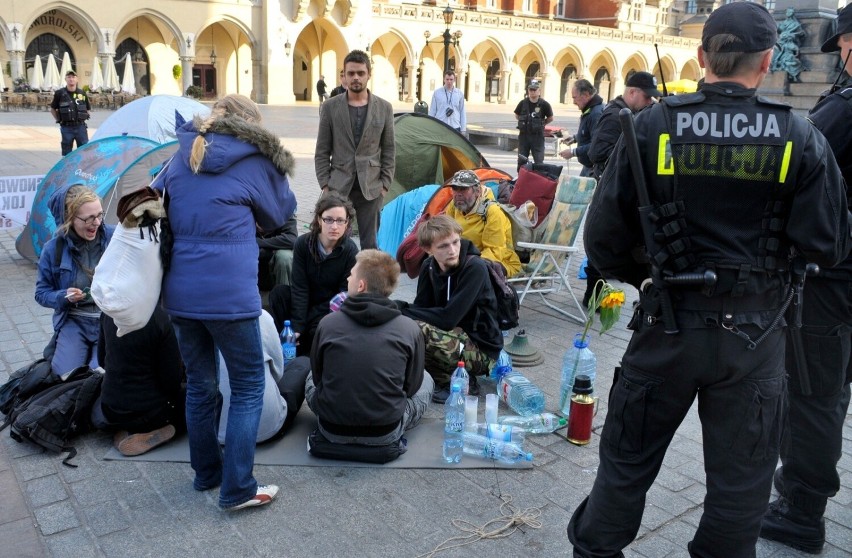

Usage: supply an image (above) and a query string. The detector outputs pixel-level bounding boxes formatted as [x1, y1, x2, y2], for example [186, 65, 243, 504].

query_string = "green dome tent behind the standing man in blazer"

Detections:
[384, 112, 489, 204]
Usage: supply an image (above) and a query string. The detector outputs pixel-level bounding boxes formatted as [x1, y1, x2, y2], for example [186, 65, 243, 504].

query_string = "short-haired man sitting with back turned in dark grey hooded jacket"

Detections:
[305, 250, 435, 446]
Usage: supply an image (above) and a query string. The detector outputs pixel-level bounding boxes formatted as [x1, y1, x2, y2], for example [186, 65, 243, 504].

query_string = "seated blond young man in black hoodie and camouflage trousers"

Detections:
[396, 215, 503, 403]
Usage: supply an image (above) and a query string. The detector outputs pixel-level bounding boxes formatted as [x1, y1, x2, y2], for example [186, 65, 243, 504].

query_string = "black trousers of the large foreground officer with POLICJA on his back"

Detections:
[568, 306, 786, 558]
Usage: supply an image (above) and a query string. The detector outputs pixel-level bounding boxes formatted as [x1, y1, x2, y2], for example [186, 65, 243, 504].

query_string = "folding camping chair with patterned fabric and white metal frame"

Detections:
[509, 172, 596, 323]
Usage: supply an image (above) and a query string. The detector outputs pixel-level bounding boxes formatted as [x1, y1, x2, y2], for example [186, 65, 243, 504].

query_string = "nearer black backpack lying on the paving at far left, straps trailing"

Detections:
[0, 366, 103, 467]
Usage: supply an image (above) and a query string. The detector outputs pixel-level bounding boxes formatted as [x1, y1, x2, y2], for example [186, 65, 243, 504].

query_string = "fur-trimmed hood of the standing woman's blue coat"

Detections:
[177, 115, 295, 178]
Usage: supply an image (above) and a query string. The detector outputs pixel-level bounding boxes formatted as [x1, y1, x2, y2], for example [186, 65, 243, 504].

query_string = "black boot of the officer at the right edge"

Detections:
[760, 497, 825, 554]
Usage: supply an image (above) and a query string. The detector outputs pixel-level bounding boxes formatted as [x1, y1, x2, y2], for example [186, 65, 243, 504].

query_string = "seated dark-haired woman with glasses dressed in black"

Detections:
[269, 191, 358, 356]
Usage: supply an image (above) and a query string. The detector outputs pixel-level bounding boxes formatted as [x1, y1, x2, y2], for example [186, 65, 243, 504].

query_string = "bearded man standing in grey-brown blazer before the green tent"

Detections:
[314, 50, 396, 250]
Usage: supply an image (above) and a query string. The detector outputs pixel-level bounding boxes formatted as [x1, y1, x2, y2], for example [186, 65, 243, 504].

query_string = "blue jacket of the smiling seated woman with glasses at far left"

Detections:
[35, 184, 115, 331]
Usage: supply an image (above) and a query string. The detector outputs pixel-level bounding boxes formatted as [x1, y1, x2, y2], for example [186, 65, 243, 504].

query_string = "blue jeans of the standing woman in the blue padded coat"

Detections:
[172, 316, 265, 508]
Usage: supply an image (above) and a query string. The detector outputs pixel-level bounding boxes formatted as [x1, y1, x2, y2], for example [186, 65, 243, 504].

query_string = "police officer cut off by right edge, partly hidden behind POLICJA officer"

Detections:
[760, 5, 852, 554]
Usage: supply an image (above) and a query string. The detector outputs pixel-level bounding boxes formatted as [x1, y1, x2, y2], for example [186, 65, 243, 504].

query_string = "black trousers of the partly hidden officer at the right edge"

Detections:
[781, 277, 852, 516]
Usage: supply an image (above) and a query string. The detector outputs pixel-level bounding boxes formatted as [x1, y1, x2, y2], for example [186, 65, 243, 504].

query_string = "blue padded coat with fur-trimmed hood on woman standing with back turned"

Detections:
[153, 115, 296, 320]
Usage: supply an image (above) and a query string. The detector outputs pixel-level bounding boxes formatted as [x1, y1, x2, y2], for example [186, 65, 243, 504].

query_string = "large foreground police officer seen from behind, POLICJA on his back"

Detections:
[568, 2, 849, 558]
